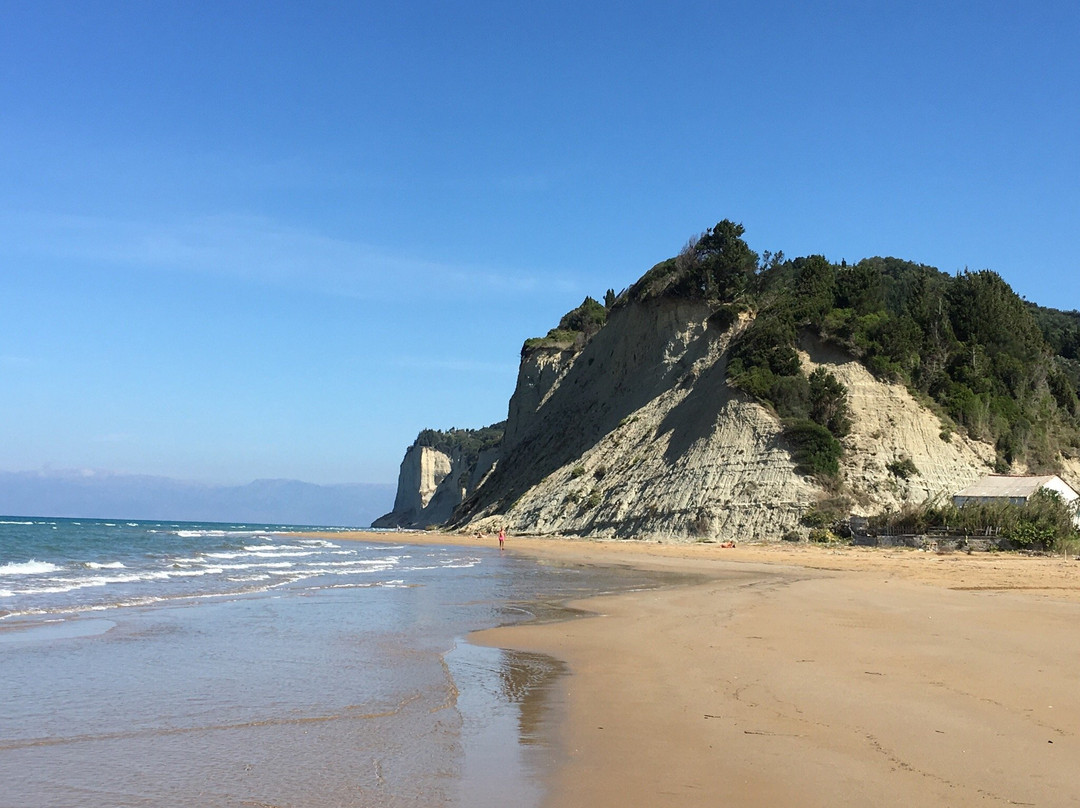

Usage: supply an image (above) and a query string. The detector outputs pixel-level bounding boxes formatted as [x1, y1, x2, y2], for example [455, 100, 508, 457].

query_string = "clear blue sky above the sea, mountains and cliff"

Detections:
[0, 0, 1080, 483]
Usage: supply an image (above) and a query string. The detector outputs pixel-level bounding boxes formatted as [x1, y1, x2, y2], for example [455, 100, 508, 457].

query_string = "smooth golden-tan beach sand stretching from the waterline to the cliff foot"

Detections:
[326, 534, 1080, 808]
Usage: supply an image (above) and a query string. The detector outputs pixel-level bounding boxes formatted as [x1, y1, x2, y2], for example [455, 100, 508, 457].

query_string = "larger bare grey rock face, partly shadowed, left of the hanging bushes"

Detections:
[454, 299, 820, 540]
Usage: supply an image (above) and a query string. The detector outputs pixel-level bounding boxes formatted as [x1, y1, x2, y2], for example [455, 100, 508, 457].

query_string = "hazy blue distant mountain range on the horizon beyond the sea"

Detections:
[0, 471, 394, 527]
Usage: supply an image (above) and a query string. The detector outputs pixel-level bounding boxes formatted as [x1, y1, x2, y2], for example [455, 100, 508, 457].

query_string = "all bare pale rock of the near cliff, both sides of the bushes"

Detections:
[436, 299, 1010, 541]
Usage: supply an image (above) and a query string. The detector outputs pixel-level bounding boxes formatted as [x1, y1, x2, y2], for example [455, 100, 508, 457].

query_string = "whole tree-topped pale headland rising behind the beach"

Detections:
[380, 220, 1080, 540]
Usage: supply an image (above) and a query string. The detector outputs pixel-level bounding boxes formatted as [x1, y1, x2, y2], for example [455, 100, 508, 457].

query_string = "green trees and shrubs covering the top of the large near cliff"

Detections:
[531, 219, 1080, 477]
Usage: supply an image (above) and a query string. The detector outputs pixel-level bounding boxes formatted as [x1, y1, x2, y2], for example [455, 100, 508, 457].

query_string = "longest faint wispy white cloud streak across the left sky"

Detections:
[0, 215, 576, 299]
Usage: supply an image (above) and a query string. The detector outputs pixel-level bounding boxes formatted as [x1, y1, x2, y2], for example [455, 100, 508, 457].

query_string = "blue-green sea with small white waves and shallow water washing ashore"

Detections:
[0, 516, 660, 808]
